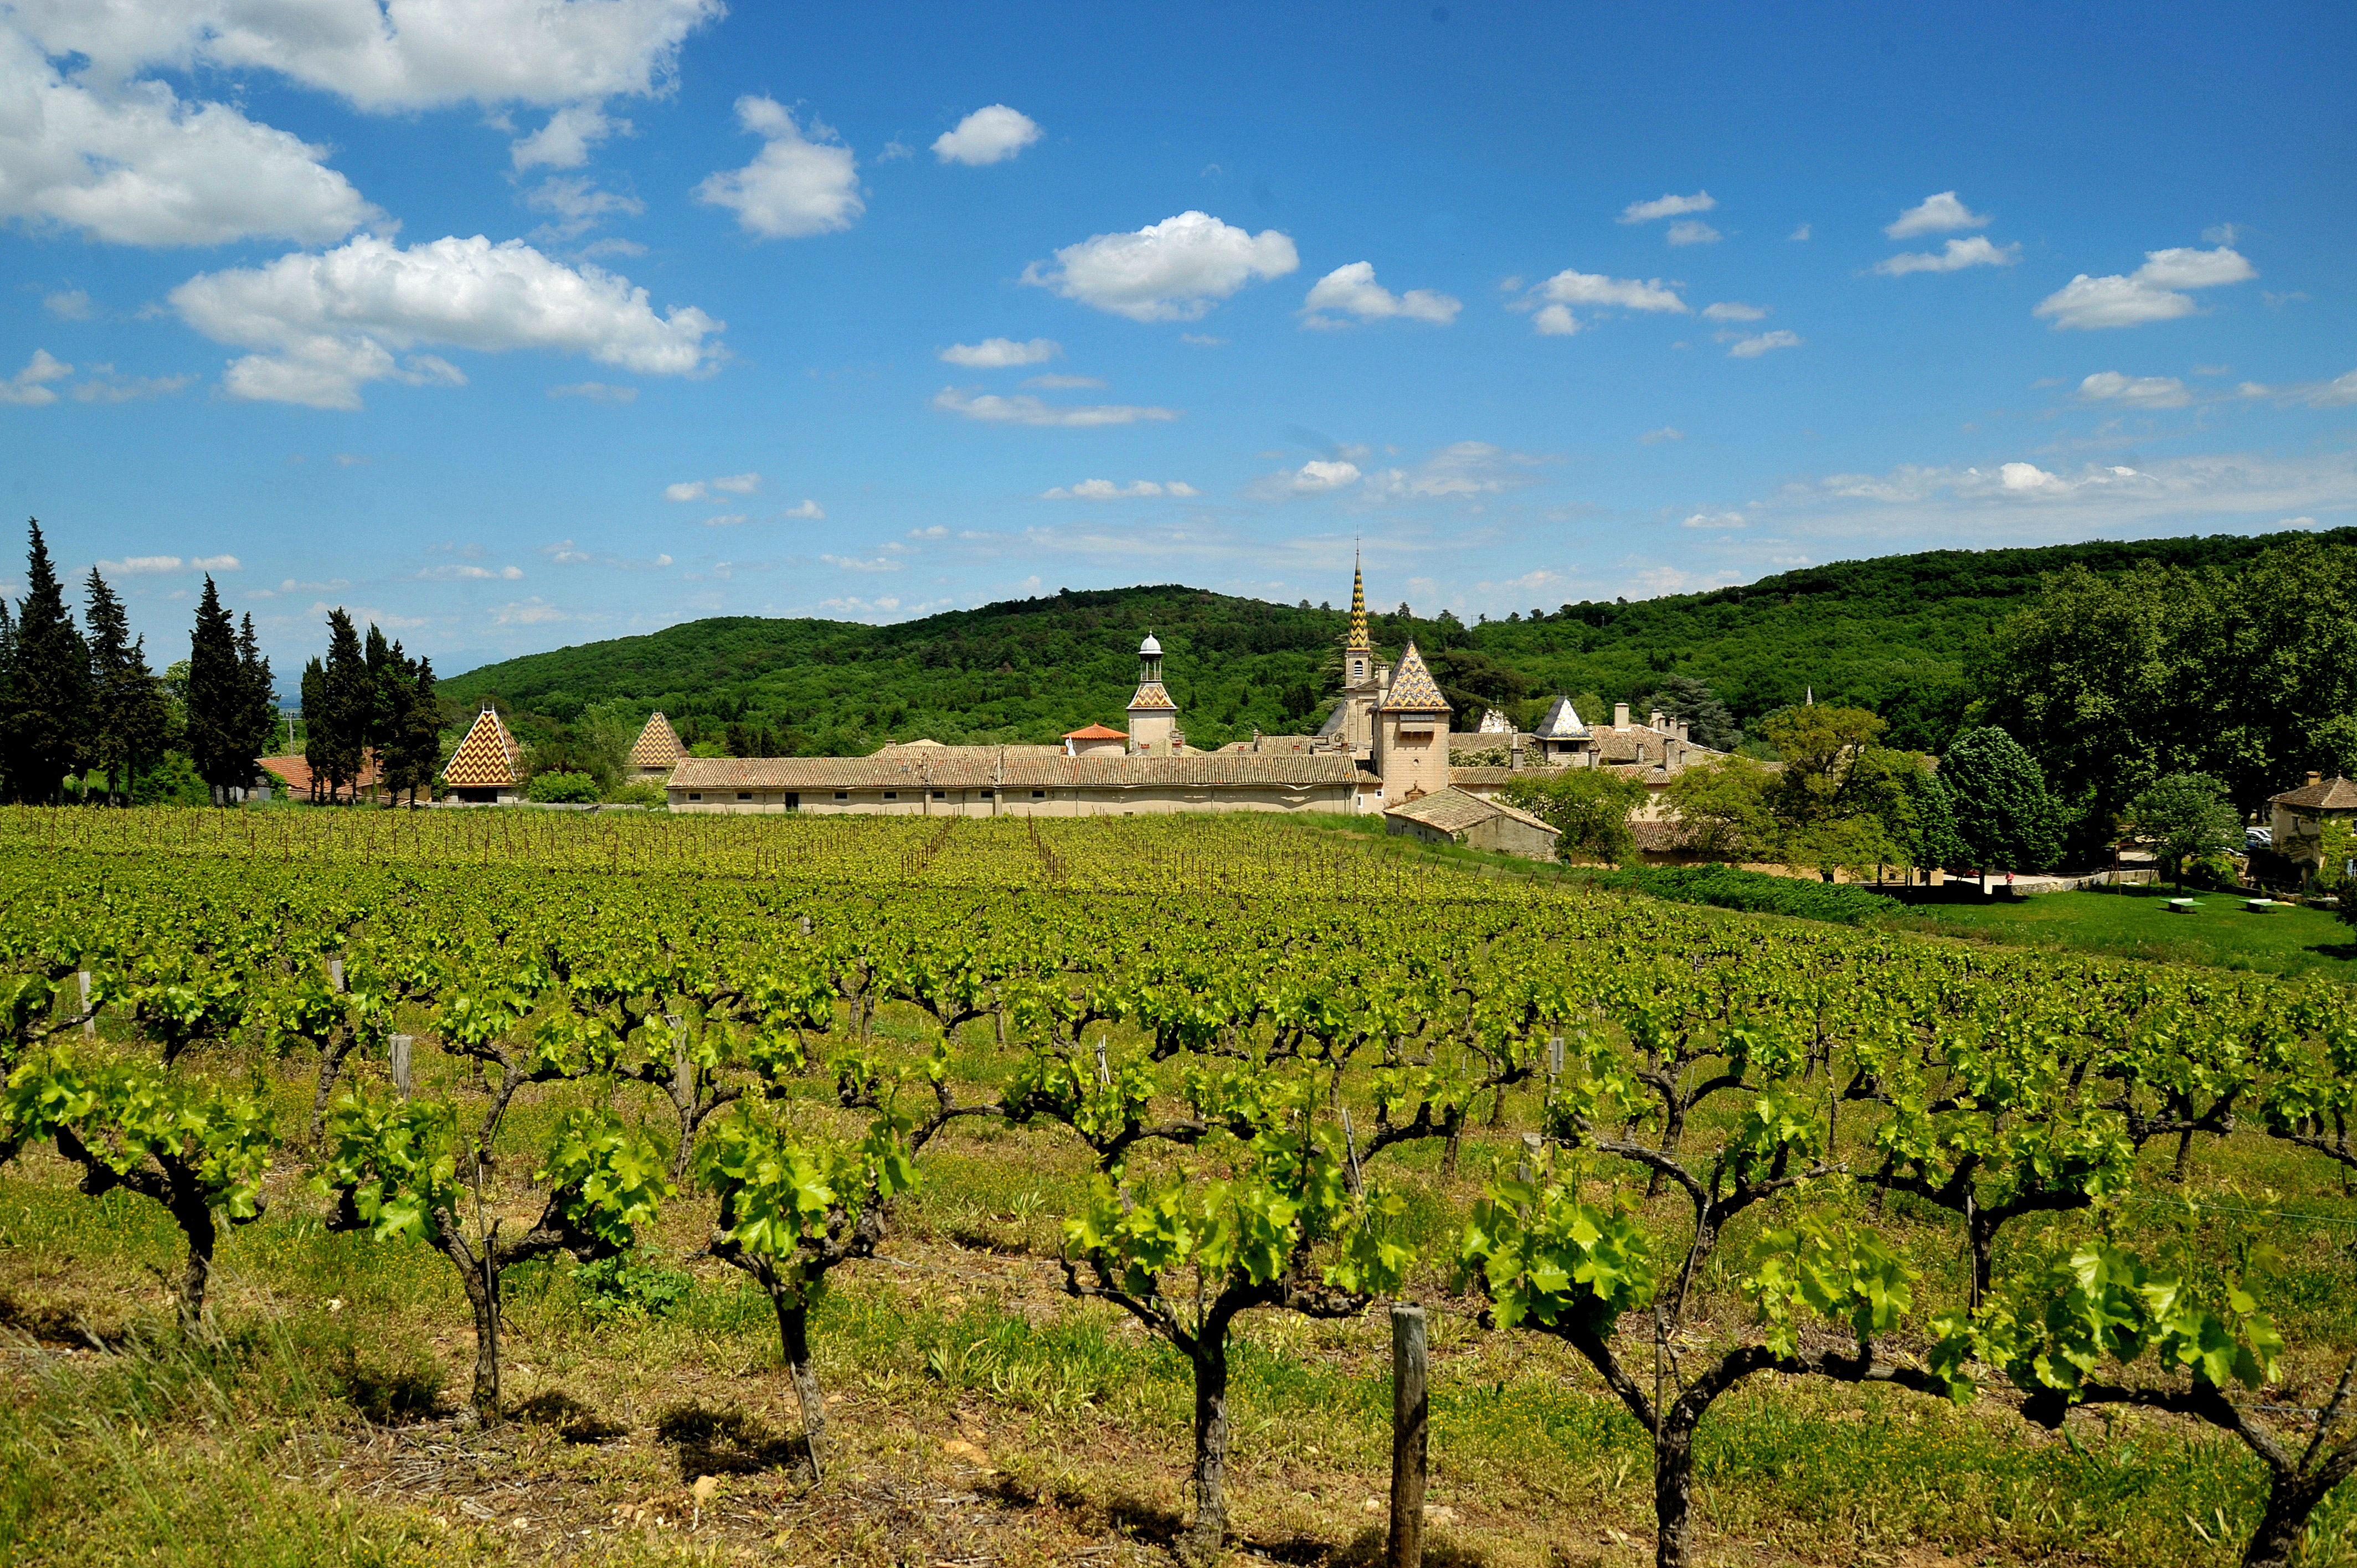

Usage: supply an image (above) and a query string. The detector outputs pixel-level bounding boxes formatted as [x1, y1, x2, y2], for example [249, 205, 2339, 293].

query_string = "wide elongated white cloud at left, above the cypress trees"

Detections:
[169, 234, 724, 408]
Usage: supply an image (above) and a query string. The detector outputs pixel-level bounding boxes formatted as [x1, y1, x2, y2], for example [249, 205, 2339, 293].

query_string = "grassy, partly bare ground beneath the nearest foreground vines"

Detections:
[0, 1056, 2357, 1568]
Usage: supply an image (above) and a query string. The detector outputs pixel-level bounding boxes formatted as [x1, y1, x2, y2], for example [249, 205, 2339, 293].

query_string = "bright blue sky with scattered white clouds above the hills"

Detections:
[0, 0, 2357, 672]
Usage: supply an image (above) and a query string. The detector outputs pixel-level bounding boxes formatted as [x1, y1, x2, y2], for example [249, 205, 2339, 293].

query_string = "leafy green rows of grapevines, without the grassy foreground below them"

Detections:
[0, 811, 2357, 1566]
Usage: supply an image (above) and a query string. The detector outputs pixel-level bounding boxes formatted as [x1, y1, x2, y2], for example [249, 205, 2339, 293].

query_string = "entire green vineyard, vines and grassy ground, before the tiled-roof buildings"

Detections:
[0, 809, 2357, 1568]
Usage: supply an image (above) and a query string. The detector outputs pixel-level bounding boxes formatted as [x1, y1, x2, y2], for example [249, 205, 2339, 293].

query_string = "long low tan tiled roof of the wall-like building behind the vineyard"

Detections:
[672, 745, 1357, 790]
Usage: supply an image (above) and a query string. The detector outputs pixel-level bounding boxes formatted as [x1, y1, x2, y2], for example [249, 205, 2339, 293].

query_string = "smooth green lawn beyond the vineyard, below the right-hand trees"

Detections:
[1881, 889, 2357, 978]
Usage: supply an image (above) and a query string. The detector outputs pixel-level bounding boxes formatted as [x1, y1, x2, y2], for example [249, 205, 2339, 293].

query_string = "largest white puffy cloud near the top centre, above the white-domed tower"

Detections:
[1023, 212, 1301, 321]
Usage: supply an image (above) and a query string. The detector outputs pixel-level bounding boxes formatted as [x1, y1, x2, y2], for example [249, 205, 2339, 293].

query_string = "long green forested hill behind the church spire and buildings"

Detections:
[441, 528, 2357, 755]
